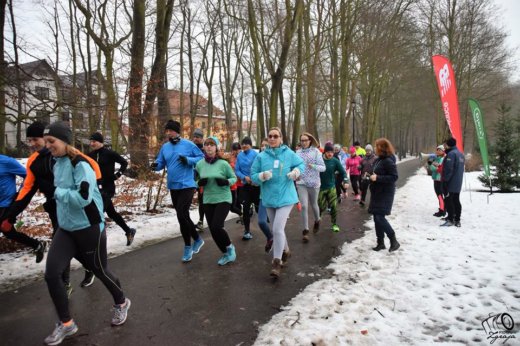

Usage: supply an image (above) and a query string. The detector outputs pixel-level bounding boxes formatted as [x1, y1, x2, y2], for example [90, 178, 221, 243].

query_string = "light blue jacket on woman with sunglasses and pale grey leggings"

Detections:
[251, 145, 305, 208]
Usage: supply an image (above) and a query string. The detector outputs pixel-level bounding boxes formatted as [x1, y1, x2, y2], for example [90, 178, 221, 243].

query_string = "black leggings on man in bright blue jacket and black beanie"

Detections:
[170, 188, 199, 246]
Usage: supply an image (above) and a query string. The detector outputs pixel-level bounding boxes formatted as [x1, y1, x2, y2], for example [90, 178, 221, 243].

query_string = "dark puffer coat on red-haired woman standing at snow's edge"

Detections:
[368, 155, 399, 215]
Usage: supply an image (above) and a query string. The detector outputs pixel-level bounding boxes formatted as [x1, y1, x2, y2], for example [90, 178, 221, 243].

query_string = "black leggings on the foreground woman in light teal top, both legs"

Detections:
[45, 225, 125, 322]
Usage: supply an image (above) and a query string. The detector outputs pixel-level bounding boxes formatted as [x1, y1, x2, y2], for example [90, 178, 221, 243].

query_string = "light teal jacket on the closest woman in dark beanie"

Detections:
[53, 155, 104, 231]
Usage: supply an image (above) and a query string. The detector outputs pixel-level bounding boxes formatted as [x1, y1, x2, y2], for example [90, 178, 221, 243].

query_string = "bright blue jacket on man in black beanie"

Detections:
[155, 138, 204, 190]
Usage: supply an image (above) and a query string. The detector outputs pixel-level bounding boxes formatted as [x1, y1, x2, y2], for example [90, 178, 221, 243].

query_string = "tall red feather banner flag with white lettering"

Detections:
[432, 55, 464, 153]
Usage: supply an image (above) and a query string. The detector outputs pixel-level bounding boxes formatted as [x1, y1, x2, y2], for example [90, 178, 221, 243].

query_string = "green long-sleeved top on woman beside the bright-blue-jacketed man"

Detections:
[195, 159, 237, 204]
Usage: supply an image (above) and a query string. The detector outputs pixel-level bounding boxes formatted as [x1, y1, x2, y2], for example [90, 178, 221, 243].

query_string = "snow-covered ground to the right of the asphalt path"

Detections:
[255, 169, 520, 346]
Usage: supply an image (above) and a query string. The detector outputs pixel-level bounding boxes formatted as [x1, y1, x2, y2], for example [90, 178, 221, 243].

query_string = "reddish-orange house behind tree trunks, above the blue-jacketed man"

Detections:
[152, 90, 237, 146]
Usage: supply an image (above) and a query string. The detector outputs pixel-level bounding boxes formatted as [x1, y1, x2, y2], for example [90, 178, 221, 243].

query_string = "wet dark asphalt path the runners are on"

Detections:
[0, 160, 418, 346]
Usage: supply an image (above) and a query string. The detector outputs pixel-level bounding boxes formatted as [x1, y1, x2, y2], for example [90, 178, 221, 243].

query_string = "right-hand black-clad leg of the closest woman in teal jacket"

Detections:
[71, 225, 125, 304]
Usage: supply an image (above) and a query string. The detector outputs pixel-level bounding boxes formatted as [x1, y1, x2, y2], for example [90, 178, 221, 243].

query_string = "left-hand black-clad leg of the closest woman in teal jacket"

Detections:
[45, 229, 77, 323]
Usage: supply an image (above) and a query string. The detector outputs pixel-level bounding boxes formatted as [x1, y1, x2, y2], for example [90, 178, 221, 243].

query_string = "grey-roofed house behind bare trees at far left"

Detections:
[5, 60, 106, 148]
